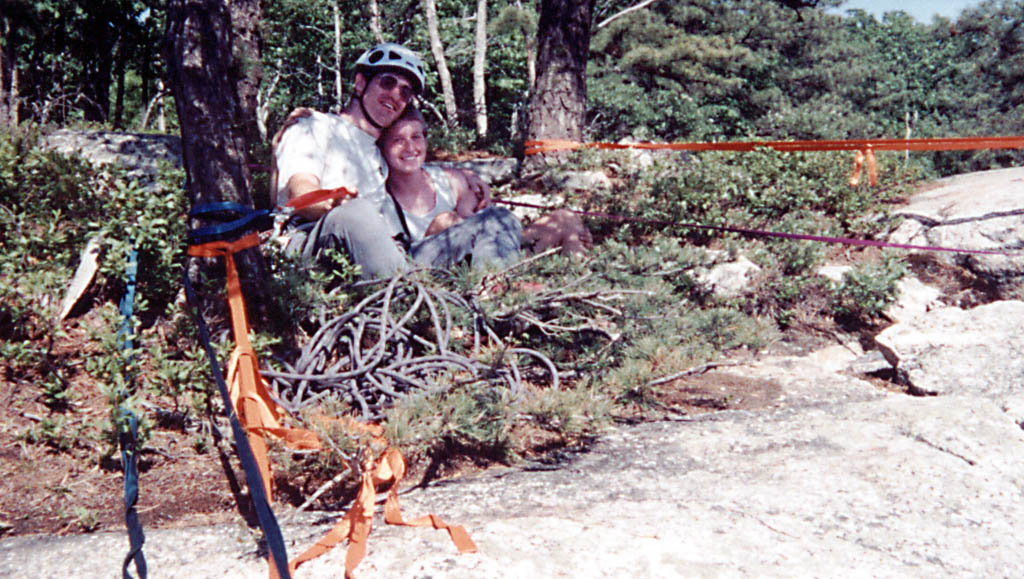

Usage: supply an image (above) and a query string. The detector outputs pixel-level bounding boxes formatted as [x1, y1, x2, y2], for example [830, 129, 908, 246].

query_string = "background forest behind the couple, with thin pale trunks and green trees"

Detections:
[6, 0, 1024, 173]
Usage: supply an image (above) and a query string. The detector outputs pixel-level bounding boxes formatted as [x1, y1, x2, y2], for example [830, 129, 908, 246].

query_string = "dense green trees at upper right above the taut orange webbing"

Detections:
[588, 0, 1024, 174]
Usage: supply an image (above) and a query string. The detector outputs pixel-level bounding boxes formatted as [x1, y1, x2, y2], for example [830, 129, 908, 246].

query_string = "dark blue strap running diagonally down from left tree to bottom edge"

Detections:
[183, 254, 291, 579]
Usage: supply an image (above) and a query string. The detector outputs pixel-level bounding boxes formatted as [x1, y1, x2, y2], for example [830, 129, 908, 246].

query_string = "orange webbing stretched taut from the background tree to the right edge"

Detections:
[525, 136, 1024, 155]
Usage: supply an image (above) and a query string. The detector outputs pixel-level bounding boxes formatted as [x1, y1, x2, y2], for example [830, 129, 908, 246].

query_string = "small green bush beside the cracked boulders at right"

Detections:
[831, 254, 906, 320]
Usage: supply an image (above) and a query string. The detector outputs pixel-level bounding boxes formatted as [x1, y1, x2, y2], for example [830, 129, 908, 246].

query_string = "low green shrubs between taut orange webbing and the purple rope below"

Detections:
[589, 149, 915, 243]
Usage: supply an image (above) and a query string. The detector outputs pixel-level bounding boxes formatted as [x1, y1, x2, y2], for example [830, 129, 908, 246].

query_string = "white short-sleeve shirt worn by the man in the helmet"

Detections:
[273, 112, 387, 209]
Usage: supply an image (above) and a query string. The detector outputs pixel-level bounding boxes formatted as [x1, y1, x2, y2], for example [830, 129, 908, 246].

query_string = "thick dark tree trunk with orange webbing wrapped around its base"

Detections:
[523, 0, 594, 172]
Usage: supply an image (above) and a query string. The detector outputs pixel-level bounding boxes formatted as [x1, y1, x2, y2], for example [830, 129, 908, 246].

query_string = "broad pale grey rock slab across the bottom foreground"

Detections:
[12, 384, 1024, 579]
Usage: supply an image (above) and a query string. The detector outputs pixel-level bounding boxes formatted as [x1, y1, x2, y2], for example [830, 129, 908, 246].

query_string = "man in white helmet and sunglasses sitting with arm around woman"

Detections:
[274, 43, 489, 278]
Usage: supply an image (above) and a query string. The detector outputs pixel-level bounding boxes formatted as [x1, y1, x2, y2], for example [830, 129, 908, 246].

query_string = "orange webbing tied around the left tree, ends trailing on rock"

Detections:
[188, 234, 476, 579]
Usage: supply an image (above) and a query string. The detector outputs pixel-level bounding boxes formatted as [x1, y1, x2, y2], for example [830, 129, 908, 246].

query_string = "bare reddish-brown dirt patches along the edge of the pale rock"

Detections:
[0, 251, 980, 538]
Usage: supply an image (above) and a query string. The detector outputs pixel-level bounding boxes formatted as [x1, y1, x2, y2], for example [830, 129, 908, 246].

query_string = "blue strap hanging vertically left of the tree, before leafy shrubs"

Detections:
[117, 247, 146, 579]
